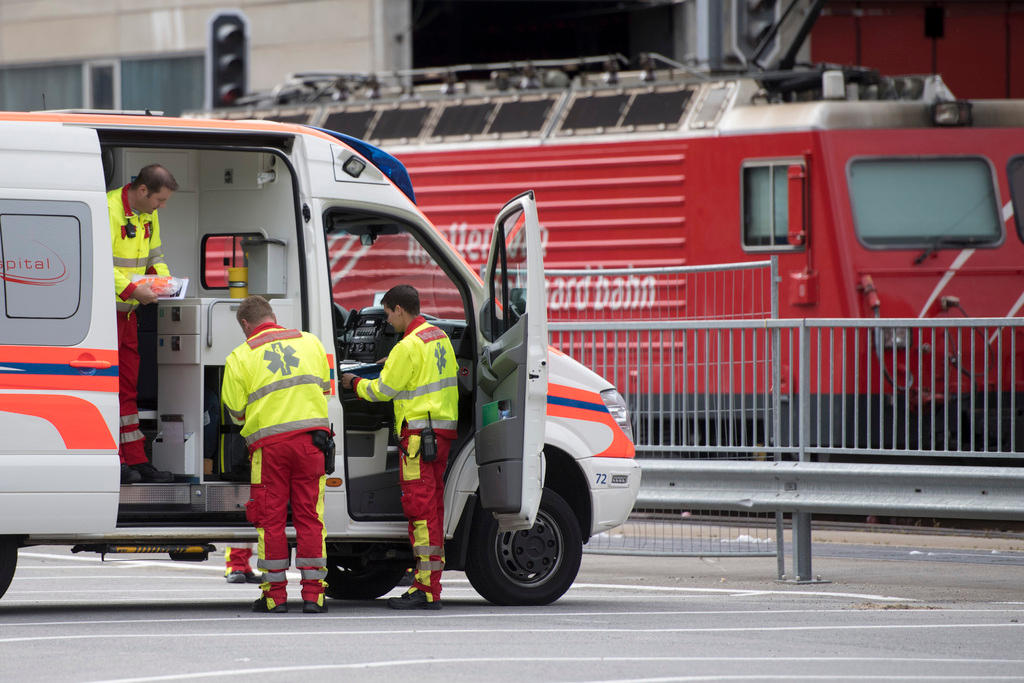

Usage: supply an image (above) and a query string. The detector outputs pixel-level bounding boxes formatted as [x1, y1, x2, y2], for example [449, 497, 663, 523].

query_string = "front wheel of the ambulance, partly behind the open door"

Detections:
[466, 488, 583, 605]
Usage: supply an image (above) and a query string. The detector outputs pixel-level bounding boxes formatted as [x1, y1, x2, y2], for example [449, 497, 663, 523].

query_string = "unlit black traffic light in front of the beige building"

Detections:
[206, 11, 249, 109]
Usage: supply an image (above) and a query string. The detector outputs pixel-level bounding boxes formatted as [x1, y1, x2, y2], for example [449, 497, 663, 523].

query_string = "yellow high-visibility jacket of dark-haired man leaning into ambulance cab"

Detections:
[354, 315, 459, 434]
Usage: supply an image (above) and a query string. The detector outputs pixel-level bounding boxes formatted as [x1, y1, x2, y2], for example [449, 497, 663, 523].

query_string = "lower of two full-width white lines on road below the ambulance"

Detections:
[0, 617, 1024, 644]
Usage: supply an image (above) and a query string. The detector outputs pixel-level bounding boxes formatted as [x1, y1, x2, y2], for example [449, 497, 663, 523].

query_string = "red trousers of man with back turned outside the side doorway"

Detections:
[246, 432, 327, 604]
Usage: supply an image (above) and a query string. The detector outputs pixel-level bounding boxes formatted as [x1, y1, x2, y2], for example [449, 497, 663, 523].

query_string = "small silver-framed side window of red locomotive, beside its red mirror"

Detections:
[741, 160, 797, 251]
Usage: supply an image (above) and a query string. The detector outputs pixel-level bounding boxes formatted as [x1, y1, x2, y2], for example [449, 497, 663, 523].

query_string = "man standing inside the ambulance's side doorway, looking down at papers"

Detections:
[106, 164, 178, 483]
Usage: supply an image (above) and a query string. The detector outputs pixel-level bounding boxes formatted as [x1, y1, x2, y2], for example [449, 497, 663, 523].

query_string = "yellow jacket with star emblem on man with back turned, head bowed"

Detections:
[220, 323, 331, 452]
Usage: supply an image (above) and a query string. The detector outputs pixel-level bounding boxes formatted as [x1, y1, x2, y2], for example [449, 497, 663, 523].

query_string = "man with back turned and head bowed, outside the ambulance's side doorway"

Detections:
[221, 296, 331, 613]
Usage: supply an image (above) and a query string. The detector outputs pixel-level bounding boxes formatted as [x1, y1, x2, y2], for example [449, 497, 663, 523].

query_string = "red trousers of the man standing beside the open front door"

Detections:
[399, 430, 452, 601]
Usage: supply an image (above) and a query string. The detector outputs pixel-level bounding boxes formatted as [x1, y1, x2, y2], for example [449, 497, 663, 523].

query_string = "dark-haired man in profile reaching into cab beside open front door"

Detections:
[341, 285, 459, 609]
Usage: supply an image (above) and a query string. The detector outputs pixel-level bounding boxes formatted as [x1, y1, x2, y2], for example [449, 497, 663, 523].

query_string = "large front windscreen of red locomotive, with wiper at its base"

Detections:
[847, 157, 1002, 249]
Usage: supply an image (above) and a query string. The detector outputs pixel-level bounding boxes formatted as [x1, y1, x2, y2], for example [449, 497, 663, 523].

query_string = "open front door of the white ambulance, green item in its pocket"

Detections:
[476, 191, 548, 530]
